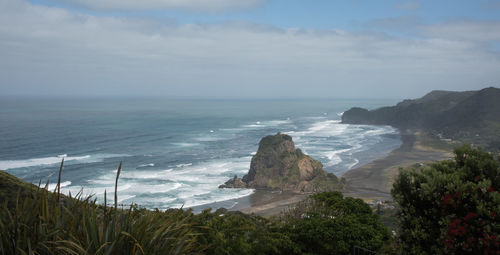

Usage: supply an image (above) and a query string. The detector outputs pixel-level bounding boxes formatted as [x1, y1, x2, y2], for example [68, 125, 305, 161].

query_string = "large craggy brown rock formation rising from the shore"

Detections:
[219, 133, 339, 192]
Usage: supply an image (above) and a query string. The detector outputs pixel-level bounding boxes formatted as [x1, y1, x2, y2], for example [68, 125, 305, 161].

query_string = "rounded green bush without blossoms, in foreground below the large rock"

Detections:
[281, 192, 389, 254]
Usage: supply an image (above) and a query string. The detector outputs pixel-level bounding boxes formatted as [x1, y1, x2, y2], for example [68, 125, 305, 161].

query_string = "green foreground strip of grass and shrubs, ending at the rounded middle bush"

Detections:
[0, 160, 389, 254]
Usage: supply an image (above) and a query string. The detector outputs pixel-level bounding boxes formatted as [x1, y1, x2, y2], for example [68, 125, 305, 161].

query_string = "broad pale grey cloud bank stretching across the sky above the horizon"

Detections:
[0, 0, 500, 97]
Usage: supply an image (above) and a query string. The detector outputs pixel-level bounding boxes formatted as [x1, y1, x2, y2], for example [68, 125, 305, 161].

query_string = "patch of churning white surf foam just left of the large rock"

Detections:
[79, 156, 253, 209]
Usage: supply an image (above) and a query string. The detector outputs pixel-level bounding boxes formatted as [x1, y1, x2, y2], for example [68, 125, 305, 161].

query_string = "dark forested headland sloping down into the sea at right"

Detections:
[342, 87, 500, 151]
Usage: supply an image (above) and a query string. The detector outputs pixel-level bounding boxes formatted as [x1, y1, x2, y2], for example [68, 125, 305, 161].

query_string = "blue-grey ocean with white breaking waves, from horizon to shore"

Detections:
[0, 98, 401, 209]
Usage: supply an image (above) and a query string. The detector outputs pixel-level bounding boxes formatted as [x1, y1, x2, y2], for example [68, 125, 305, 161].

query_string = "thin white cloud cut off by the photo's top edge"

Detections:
[45, 0, 264, 11]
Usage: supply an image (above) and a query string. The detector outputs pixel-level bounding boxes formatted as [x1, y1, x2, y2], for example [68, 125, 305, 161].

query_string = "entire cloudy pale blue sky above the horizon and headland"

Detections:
[0, 0, 500, 98]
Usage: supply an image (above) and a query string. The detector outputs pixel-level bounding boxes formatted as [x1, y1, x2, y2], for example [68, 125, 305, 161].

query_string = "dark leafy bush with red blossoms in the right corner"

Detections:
[392, 145, 500, 254]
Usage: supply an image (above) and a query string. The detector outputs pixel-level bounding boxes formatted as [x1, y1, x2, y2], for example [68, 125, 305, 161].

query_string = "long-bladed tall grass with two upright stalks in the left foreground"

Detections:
[0, 160, 205, 255]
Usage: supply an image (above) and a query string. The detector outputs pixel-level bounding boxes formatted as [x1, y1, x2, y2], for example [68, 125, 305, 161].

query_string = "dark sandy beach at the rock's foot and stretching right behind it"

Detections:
[231, 130, 452, 217]
